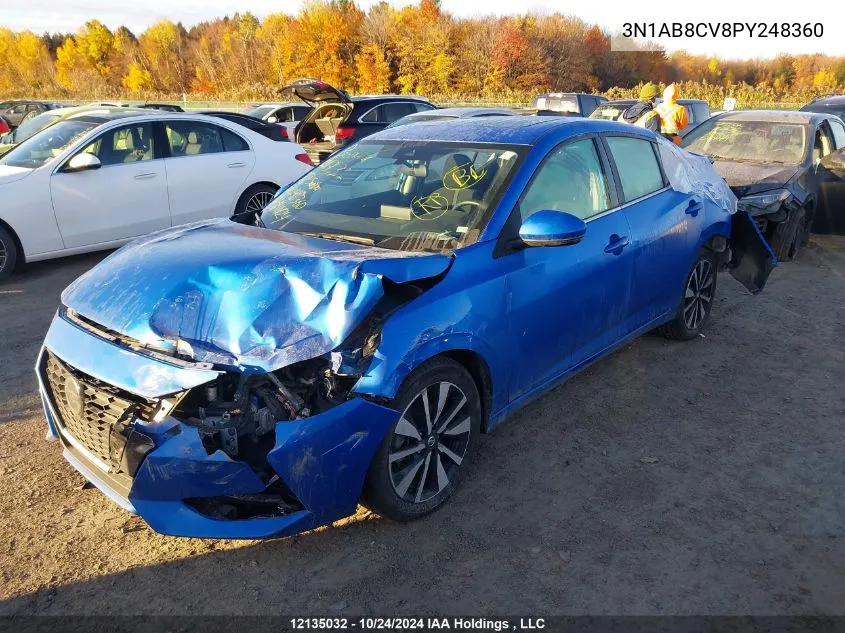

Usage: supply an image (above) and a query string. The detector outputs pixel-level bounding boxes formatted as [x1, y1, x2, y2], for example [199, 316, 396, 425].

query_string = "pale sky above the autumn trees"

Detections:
[0, 0, 845, 59]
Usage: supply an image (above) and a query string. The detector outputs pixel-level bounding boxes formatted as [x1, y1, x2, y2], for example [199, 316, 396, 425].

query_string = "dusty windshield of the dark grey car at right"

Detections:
[682, 119, 807, 165]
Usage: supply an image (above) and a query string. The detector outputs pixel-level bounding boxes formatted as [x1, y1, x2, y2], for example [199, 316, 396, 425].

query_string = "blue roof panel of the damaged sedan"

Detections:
[370, 116, 636, 145]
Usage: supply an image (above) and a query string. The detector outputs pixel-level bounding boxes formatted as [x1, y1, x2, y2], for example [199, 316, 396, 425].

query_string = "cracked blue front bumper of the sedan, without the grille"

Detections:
[36, 315, 399, 538]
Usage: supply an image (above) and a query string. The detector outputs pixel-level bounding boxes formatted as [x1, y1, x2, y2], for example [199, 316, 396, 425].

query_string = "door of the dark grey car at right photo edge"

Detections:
[813, 119, 845, 235]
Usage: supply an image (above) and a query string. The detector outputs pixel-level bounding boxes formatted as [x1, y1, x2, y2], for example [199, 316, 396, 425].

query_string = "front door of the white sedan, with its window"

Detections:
[50, 122, 170, 248]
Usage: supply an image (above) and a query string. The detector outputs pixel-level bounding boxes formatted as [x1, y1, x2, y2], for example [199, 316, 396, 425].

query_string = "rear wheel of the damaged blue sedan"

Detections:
[658, 248, 719, 341]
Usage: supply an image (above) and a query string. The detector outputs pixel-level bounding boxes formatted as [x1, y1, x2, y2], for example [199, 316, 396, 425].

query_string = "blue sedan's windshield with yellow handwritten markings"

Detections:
[261, 141, 521, 252]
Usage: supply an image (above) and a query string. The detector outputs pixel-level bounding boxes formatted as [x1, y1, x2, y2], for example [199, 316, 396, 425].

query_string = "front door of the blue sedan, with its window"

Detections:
[501, 135, 631, 399]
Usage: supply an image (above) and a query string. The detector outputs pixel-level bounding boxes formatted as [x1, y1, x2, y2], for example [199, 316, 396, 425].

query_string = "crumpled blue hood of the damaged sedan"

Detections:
[62, 220, 452, 372]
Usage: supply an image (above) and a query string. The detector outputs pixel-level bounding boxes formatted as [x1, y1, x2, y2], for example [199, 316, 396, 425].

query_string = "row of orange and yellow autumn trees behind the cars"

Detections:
[0, 0, 845, 106]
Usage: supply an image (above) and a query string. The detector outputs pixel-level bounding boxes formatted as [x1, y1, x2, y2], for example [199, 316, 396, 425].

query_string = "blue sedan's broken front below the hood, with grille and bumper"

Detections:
[37, 308, 398, 538]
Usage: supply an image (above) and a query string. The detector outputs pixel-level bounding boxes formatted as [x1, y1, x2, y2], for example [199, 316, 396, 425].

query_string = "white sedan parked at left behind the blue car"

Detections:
[0, 113, 311, 278]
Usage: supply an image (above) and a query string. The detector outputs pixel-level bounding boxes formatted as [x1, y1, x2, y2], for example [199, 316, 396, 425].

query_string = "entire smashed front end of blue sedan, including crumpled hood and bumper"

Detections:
[36, 220, 450, 538]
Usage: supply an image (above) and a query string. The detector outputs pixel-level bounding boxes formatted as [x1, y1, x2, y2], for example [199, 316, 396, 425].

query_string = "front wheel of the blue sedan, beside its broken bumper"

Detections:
[362, 358, 482, 521]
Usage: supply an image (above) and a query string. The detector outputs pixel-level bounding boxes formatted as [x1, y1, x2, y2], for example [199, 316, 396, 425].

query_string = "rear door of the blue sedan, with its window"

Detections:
[605, 135, 705, 330]
